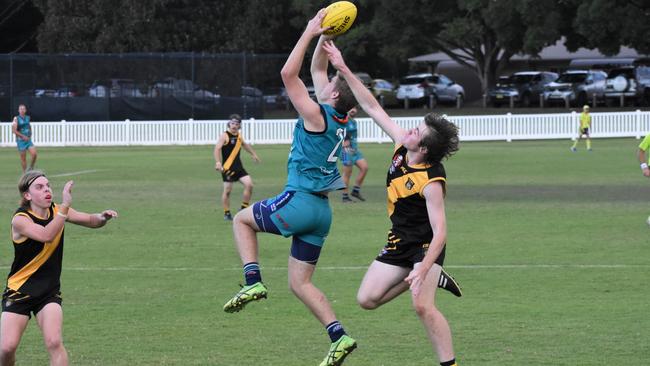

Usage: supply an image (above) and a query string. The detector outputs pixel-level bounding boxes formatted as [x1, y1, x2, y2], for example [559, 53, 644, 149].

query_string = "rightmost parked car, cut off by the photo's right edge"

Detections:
[605, 65, 650, 105]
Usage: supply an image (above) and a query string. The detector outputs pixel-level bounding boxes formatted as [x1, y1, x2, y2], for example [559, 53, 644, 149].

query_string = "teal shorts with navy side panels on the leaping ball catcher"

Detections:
[253, 191, 332, 247]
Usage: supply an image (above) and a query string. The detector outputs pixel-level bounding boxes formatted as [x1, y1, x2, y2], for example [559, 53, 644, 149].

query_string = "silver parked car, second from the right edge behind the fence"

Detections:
[544, 70, 607, 106]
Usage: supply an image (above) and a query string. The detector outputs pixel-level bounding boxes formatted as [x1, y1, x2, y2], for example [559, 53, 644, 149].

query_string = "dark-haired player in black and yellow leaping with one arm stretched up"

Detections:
[324, 42, 458, 366]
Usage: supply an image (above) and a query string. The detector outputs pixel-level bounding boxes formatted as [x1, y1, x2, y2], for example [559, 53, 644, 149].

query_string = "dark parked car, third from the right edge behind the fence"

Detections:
[487, 71, 558, 107]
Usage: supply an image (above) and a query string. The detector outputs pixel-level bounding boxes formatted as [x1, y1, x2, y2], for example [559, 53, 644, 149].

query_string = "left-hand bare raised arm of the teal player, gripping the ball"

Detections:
[280, 9, 326, 131]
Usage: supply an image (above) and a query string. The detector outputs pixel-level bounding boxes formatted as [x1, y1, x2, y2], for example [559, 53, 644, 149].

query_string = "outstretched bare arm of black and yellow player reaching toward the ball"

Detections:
[323, 41, 406, 143]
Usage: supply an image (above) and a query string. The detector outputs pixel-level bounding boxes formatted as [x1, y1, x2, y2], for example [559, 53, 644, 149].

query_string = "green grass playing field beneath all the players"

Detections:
[0, 139, 650, 366]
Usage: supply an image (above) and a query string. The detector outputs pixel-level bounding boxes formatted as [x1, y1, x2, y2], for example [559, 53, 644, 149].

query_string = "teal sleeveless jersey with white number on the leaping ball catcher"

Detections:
[285, 104, 347, 193]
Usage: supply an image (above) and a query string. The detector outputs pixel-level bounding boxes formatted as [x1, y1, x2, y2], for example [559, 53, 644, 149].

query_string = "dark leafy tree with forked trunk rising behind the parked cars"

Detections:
[364, 0, 575, 91]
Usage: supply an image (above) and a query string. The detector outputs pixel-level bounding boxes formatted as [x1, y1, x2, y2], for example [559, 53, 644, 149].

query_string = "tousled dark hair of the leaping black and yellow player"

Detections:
[420, 113, 458, 164]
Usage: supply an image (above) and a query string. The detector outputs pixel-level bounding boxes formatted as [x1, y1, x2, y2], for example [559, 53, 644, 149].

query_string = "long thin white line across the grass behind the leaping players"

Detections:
[0, 264, 650, 272]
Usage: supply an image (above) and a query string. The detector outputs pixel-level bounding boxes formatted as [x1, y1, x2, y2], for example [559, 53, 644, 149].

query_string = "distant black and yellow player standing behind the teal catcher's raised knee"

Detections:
[214, 114, 261, 221]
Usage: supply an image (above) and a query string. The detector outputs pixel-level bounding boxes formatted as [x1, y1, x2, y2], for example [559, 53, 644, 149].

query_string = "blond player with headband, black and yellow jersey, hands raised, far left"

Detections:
[0, 170, 117, 365]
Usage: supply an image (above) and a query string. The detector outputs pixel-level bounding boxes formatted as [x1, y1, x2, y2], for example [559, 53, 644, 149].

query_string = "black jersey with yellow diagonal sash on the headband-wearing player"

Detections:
[7, 204, 64, 297]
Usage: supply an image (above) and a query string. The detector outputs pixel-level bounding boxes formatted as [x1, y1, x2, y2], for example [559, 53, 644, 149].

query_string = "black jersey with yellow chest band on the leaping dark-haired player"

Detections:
[386, 145, 446, 244]
